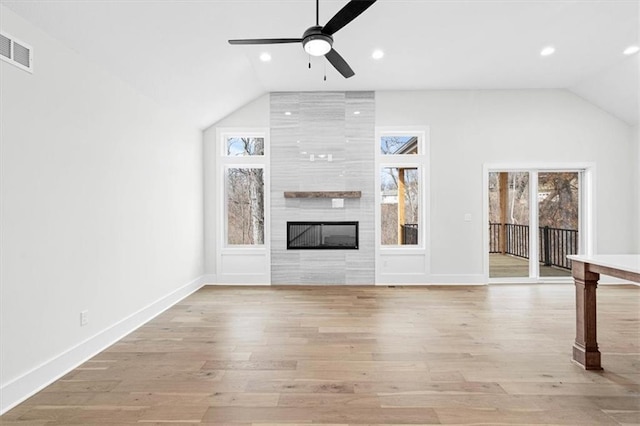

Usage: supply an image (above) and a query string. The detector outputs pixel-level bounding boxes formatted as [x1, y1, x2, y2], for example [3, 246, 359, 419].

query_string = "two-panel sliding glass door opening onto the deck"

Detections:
[486, 168, 583, 281]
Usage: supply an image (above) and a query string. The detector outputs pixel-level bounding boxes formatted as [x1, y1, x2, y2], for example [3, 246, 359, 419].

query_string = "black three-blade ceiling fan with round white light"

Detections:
[229, 0, 376, 78]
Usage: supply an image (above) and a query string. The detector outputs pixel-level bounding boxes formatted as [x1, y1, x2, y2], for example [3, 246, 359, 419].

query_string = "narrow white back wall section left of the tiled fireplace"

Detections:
[204, 94, 270, 283]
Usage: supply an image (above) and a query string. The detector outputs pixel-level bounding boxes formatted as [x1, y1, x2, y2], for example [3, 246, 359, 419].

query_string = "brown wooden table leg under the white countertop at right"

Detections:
[572, 260, 602, 370]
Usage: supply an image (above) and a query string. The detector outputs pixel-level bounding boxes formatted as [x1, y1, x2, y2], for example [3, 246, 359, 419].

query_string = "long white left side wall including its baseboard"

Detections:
[0, 6, 203, 410]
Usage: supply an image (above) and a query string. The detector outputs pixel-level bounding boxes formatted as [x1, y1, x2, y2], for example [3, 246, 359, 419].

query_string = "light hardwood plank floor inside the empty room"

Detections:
[0, 285, 640, 425]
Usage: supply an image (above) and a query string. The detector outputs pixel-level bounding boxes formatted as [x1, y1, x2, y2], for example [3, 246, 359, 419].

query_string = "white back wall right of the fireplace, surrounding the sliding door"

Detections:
[376, 90, 637, 281]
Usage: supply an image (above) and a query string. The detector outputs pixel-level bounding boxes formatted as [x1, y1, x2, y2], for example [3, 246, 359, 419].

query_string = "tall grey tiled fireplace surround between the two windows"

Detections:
[270, 92, 375, 285]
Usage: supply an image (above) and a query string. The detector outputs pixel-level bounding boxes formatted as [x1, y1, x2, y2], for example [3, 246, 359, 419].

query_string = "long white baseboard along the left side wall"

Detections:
[0, 276, 205, 415]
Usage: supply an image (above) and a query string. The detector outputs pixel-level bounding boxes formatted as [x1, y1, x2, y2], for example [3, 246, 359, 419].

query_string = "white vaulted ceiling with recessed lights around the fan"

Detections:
[2, 0, 640, 128]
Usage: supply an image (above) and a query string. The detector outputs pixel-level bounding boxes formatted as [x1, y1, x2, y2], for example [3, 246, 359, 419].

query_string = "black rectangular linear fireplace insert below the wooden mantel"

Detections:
[287, 222, 358, 250]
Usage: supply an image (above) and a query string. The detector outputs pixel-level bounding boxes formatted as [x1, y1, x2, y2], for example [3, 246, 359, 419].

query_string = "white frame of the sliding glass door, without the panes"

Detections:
[482, 163, 595, 284]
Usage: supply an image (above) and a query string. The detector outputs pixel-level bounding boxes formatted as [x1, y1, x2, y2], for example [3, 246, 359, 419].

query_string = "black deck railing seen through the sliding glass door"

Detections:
[489, 223, 578, 269]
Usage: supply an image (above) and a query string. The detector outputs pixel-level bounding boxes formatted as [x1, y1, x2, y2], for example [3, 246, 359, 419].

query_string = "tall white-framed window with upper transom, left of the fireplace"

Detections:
[220, 132, 268, 247]
